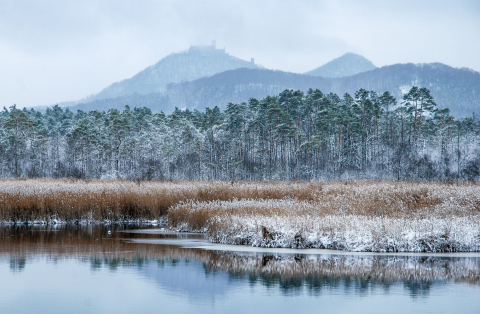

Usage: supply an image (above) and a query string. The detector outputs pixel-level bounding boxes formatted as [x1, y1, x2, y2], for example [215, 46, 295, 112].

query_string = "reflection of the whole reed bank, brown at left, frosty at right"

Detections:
[0, 226, 480, 287]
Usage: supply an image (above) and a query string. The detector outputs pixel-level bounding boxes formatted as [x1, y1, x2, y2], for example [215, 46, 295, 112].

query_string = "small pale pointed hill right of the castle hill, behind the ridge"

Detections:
[305, 52, 376, 77]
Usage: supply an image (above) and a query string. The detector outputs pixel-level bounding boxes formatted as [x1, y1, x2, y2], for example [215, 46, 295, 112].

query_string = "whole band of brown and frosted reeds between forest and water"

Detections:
[0, 180, 480, 252]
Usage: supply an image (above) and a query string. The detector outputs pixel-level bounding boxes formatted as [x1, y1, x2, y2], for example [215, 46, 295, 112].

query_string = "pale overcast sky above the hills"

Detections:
[0, 0, 480, 108]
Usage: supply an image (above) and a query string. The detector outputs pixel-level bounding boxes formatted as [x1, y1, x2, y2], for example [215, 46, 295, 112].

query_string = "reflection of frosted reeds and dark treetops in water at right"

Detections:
[199, 252, 480, 296]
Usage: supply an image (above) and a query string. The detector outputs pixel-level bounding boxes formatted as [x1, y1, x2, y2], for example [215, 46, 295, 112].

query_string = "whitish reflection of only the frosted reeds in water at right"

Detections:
[206, 252, 480, 285]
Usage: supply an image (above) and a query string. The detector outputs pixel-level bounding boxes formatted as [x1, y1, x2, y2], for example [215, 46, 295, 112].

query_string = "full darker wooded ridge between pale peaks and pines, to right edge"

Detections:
[71, 63, 480, 117]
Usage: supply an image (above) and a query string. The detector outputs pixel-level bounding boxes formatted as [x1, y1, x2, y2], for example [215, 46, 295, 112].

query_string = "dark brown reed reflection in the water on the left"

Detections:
[0, 225, 202, 261]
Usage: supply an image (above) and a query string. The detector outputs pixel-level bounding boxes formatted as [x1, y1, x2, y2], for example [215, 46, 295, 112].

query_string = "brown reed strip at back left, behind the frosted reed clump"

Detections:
[0, 179, 318, 223]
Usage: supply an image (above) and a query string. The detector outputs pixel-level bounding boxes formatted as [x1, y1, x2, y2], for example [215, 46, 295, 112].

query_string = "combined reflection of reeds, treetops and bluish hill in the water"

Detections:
[0, 226, 480, 298]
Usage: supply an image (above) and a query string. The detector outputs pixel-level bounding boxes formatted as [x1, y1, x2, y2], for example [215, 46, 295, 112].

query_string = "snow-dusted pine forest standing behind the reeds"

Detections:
[0, 87, 480, 180]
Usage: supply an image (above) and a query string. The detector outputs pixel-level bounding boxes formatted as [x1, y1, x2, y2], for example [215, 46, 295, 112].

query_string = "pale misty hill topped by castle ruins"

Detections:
[80, 43, 257, 102]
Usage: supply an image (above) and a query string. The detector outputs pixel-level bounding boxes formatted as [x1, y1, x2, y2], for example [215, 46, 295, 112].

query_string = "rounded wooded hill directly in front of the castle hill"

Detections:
[69, 68, 330, 113]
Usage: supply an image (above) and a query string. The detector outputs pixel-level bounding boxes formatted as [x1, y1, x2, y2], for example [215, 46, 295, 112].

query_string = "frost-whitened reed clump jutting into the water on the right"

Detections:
[169, 182, 480, 252]
